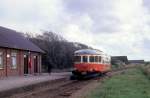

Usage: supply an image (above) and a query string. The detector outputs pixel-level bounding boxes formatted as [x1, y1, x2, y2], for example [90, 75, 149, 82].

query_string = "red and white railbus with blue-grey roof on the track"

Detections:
[72, 49, 111, 76]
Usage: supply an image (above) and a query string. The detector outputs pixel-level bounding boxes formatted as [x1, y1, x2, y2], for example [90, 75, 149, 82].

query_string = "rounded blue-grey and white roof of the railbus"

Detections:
[75, 49, 103, 55]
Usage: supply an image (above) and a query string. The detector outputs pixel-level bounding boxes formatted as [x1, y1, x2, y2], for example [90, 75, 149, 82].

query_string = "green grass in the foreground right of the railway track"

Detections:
[84, 69, 150, 98]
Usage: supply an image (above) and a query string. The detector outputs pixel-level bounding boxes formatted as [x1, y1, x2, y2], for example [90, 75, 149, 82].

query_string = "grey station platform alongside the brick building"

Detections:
[0, 72, 71, 98]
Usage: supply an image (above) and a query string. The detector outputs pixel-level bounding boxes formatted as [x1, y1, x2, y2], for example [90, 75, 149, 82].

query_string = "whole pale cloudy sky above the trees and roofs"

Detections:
[0, 0, 150, 61]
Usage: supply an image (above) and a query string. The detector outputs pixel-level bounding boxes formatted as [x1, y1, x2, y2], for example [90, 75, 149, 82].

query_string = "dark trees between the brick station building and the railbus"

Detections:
[26, 31, 91, 69]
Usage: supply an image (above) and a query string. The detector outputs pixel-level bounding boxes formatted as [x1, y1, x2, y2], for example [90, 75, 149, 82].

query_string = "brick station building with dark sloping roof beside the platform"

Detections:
[0, 26, 43, 78]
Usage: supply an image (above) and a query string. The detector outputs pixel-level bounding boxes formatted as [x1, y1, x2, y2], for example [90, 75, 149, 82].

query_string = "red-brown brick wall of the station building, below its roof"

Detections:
[0, 48, 41, 77]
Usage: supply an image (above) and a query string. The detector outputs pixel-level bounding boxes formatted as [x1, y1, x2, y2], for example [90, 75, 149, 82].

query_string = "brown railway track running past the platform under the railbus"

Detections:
[8, 67, 134, 98]
